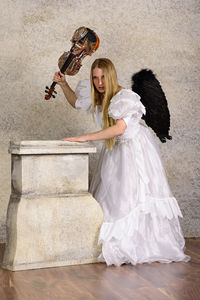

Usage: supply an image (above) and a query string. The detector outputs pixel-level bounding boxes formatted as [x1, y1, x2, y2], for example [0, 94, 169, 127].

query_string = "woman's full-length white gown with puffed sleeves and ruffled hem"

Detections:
[75, 80, 190, 266]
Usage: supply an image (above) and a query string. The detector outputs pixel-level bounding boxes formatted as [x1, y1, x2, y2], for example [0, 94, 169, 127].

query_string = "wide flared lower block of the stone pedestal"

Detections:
[2, 193, 102, 271]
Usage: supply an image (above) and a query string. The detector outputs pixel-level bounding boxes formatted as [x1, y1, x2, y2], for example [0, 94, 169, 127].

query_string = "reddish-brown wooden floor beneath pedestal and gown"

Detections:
[0, 238, 200, 300]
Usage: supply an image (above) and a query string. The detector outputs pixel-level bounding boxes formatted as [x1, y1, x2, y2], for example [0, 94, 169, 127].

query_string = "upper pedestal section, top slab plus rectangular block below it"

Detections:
[9, 141, 96, 194]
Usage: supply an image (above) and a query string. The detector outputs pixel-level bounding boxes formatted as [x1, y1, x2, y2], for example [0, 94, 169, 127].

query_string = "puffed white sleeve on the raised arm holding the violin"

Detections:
[75, 79, 92, 113]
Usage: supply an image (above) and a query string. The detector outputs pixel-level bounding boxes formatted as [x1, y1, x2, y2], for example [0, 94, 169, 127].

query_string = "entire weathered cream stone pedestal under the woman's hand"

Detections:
[2, 141, 103, 271]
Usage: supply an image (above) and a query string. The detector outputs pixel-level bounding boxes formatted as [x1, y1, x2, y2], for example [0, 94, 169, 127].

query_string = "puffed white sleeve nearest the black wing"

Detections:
[108, 89, 146, 125]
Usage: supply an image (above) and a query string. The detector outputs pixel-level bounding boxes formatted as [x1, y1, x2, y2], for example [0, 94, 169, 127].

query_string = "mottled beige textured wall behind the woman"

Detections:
[0, 0, 200, 241]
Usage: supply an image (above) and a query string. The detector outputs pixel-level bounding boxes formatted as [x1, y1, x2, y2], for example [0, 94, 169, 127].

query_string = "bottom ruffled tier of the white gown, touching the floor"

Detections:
[99, 212, 190, 266]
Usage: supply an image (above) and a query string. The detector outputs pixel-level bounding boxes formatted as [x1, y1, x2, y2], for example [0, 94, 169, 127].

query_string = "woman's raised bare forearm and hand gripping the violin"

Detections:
[53, 72, 77, 107]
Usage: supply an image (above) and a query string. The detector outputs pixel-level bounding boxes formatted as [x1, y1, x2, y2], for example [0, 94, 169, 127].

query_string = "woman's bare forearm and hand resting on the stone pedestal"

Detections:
[62, 119, 126, 142]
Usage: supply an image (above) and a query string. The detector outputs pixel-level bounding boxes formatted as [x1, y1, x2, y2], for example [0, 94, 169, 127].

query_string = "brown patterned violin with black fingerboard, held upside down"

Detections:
[45, 27, 100, 100]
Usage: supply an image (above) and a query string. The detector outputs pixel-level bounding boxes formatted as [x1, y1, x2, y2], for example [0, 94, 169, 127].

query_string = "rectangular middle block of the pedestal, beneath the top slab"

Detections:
[12, 154, 88, 194]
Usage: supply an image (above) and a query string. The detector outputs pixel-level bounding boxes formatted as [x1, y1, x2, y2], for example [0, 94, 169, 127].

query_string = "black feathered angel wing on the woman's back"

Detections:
[132, 69, 172, 143]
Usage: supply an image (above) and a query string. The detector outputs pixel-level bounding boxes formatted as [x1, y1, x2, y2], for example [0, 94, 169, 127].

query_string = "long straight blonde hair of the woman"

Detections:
[90, 58, 121, 149]
